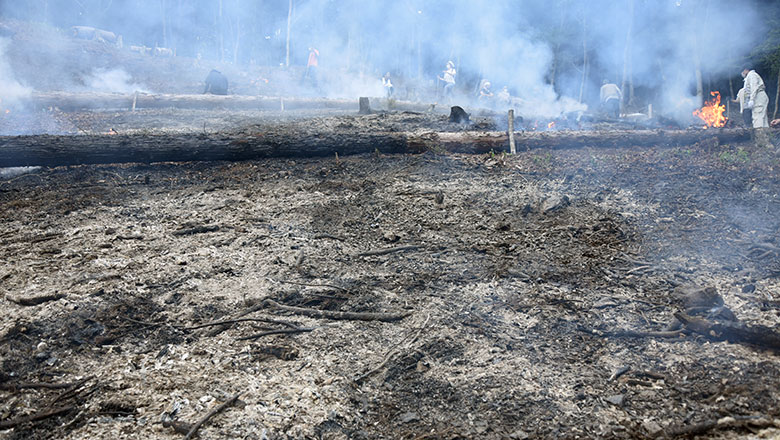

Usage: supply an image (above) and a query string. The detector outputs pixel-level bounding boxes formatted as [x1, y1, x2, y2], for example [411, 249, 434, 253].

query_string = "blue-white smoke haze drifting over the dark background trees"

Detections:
[0, 0, 780, 114]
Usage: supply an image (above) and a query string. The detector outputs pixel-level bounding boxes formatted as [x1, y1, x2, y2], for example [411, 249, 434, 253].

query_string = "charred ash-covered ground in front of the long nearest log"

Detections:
[0, 111, 780, 439]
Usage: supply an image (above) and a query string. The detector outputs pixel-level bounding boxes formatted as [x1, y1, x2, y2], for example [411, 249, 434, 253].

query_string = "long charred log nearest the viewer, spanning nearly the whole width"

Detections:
[0, 129, 750, 167]
